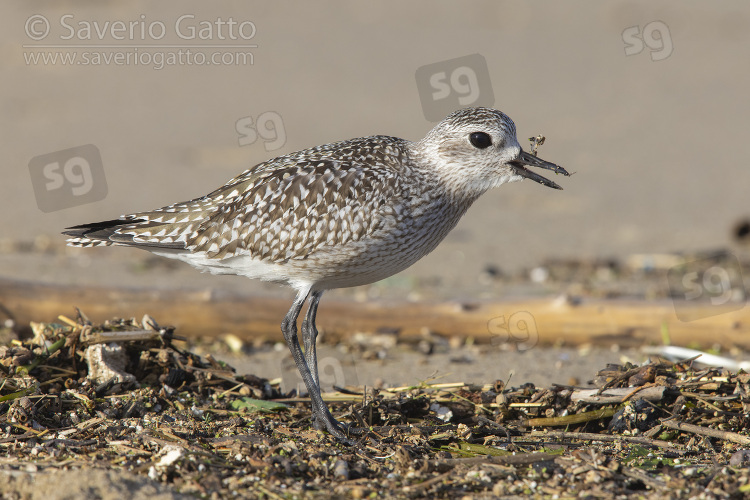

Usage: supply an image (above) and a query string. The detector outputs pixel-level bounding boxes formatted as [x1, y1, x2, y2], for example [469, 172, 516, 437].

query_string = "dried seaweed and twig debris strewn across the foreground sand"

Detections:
[0, 314, 750, 498]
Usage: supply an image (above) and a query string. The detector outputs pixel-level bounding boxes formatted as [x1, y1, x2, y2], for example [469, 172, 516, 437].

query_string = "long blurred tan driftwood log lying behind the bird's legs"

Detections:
[0, 279, 750, 350]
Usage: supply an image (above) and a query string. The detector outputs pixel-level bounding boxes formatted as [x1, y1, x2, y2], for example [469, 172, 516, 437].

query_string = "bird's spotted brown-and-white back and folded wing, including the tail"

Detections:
[65, 136, 412, 262]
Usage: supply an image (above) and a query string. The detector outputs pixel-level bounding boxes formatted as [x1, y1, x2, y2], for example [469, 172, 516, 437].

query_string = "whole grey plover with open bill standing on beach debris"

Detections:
[63, 108, 570, 442]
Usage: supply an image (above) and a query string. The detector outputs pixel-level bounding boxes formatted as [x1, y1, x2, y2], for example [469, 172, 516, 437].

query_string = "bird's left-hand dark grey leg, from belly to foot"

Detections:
[281, 290, 353, 444]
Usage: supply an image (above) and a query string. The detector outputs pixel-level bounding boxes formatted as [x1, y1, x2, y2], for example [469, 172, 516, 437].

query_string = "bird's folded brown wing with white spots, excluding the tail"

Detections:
[188, 138, 404, 262]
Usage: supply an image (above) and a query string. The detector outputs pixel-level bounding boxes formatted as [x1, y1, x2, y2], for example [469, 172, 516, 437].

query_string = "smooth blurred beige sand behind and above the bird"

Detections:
[0, 1, 750, 295]
